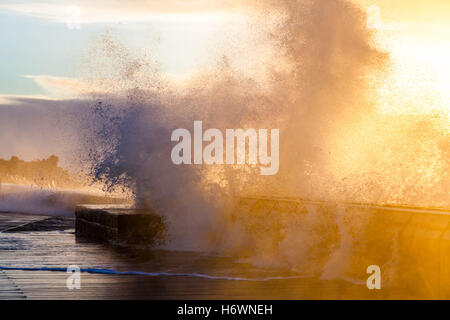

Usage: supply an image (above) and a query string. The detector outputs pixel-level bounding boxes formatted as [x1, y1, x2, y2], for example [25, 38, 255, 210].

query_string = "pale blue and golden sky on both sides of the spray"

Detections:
[0, 0, 450, 101]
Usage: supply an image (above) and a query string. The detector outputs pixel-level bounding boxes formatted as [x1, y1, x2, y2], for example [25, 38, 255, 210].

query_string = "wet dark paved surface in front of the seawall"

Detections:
[0, 213, 416, 299]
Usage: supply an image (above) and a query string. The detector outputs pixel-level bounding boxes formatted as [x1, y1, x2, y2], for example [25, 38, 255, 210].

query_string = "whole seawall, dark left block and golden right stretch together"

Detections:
[76, 197, 450, 298]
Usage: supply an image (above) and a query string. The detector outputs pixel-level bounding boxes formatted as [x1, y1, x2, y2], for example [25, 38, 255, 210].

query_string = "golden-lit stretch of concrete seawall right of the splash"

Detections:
[233, 197, 450, 298]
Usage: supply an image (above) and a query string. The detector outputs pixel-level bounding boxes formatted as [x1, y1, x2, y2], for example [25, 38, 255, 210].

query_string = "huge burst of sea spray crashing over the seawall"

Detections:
[75, 0, 449, 277]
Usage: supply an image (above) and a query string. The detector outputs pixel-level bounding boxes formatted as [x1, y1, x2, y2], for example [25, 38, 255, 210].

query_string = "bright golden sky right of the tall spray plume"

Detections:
[355, 0, 450, 116]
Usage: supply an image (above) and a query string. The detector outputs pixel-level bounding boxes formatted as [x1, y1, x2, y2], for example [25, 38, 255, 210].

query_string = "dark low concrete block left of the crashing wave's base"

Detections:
[75, 205, 166, 245]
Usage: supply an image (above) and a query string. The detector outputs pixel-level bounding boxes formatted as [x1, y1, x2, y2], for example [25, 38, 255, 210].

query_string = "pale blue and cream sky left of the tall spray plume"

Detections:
[0, 0, 246, 96]
